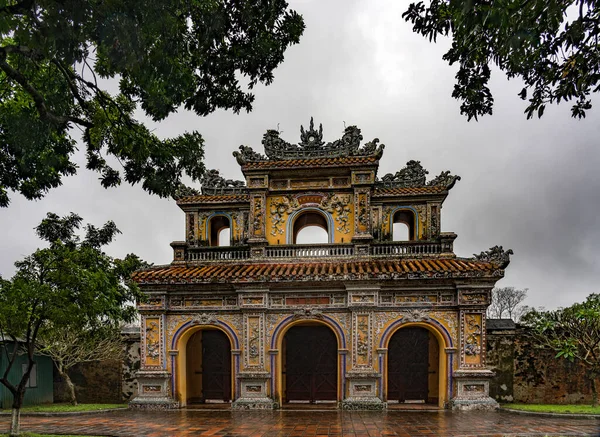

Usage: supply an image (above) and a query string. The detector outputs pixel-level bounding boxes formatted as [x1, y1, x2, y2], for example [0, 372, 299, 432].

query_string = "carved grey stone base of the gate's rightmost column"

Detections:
[450, 370, 499, 411]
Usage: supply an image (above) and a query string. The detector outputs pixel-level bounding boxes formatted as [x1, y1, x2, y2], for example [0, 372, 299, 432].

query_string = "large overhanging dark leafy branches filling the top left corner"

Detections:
[0, 0, 304, 206]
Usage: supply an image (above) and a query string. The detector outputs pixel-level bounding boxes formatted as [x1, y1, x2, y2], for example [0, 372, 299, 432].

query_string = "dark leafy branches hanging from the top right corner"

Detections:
[403, 0, 600, 120]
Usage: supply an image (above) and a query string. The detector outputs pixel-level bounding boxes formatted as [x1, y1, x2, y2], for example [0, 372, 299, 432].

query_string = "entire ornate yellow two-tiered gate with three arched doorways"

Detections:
[132, 120, 512, 409]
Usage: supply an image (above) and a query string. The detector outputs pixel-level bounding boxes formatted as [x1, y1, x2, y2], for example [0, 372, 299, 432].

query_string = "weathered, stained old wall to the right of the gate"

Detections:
[487, 323, 600, 404]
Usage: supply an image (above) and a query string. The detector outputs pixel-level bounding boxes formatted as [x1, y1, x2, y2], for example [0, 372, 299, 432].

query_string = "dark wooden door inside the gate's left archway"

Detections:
[202, 330, 231, 402]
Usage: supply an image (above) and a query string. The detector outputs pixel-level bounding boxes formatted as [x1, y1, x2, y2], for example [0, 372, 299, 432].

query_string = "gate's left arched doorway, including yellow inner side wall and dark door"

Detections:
[186, 329, 231, 404]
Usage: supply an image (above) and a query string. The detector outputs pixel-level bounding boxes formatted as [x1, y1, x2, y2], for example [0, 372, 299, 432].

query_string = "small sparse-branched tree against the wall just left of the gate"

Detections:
[38, 326, 124, 405]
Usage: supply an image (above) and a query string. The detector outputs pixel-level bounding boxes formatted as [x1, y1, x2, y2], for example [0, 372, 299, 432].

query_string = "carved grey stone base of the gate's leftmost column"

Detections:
[129, 370, 179, 410]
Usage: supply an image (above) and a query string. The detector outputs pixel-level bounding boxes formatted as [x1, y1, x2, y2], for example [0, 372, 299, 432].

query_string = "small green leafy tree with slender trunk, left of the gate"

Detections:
[0, 213, 144, 435]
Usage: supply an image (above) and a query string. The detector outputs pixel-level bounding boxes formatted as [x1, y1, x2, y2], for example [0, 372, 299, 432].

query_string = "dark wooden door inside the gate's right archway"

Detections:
[388, 328, 429, 402]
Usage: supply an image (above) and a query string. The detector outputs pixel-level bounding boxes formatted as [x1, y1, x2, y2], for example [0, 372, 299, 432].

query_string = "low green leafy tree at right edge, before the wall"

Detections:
[521, 294, 600, 406]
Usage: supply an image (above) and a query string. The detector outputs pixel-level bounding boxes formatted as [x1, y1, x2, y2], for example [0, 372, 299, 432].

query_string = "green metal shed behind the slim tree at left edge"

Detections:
[0, 342, 54, 409]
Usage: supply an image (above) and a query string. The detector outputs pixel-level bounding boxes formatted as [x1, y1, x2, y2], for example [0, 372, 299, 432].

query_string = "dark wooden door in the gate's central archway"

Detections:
[284, 326, 337, 402]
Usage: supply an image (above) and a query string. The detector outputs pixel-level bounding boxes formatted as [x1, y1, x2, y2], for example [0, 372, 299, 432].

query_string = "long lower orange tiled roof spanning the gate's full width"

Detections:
[133, 258, 504, 284]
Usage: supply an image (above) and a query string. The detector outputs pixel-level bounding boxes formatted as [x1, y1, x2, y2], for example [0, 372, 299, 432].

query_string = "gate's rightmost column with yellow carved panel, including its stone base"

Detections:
[450, 288, 498, 410]
